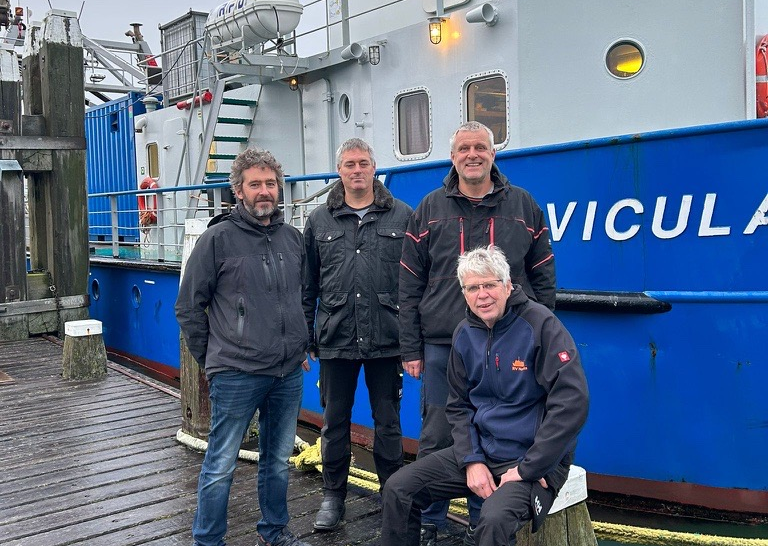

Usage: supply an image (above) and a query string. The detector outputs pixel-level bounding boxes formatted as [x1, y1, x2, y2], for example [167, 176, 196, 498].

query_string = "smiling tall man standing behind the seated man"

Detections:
[399, 121, 555, 546]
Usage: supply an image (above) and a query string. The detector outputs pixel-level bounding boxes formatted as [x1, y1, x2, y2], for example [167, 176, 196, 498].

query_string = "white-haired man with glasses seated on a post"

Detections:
[381, 246, 589, 546]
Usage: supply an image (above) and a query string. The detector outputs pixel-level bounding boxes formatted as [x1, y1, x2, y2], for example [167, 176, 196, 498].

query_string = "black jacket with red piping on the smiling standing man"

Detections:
[399, 165, 555, 361]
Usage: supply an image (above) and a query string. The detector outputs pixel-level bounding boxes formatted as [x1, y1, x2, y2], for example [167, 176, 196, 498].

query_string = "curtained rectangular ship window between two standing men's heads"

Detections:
[395, 90, 432, 159]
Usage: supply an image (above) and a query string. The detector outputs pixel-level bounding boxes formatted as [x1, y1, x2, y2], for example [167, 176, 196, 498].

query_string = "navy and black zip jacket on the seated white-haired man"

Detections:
[446, 285, 589, 481]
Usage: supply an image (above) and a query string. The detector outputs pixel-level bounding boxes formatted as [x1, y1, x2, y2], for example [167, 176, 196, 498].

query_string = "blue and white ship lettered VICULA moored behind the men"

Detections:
[10, 0, 768, 515]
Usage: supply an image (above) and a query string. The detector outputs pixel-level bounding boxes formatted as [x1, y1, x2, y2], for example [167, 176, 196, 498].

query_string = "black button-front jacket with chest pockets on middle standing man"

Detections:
[304, 179, 412, 359]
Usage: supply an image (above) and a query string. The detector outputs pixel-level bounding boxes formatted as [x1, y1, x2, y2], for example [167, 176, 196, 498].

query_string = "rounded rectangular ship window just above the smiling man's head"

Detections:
[464, 74, 508, 145]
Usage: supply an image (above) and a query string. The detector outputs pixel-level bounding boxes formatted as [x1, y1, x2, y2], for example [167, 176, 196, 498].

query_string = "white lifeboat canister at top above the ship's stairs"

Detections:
[205, 0, 304, 49]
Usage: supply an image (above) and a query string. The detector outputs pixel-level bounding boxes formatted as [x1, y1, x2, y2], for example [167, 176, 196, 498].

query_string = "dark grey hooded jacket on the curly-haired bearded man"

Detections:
[176, 204, 307, 378]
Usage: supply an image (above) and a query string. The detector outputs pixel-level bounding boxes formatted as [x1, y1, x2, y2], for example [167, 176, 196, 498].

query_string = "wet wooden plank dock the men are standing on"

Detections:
[0, 338, 463, 546]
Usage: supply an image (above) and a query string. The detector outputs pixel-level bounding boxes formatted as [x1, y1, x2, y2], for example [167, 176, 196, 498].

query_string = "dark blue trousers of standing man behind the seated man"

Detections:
[416, 343, 483, 528]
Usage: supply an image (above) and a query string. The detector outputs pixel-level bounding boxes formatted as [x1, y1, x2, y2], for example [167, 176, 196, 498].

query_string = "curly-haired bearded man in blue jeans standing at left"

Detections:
[176, 149, 309, 546]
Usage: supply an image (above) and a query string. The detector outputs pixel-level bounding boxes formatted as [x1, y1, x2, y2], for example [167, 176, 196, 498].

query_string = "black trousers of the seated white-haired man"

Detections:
[381, 447, 568, 546]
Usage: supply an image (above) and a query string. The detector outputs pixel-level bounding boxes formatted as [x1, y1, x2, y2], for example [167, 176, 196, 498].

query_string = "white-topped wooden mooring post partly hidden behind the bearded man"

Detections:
[179, 218, 211, 440]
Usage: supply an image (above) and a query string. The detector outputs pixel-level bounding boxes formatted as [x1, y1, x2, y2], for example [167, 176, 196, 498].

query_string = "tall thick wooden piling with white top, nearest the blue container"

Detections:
[23, 10, 89, 331]
